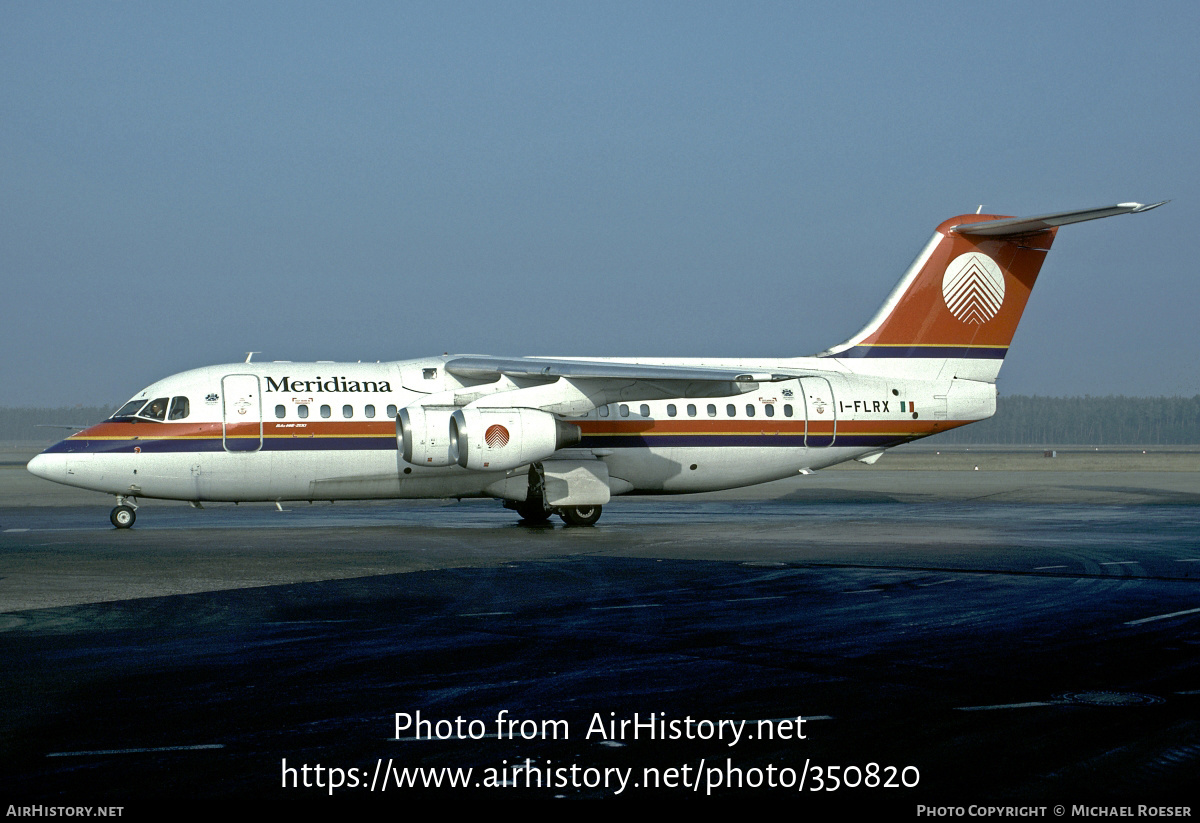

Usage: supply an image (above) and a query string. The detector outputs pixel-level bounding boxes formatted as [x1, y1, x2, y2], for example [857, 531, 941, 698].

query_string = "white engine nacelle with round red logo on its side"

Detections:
[450, 408, 581, 471]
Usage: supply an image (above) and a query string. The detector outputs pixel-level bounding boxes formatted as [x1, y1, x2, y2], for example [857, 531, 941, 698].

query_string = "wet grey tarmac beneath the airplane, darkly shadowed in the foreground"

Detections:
[0, 451, 1200, 816]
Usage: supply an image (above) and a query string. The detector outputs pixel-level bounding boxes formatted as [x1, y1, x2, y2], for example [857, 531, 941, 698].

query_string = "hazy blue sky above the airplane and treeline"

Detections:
[0, 0, 1200, 406]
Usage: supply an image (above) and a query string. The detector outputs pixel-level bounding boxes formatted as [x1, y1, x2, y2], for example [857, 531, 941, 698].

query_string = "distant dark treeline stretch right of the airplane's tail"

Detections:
[935, 395, 1200, 446]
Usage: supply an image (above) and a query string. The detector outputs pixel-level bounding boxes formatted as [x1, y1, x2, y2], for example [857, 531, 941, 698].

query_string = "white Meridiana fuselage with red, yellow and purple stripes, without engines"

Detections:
[30, 358, 995, 501]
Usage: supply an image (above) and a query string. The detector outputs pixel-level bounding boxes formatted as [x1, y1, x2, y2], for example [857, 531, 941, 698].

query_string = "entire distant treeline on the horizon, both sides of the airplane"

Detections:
[0, 395, 1200, 446]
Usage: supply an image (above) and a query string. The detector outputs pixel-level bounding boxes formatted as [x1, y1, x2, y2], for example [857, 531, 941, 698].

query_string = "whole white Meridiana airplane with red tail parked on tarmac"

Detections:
[29, 203, 1162, 529]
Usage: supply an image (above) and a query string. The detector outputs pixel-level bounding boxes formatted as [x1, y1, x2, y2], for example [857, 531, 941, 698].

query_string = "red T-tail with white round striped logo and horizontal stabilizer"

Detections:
[821, 200, 1165, 383]
